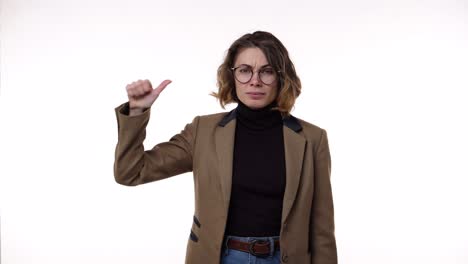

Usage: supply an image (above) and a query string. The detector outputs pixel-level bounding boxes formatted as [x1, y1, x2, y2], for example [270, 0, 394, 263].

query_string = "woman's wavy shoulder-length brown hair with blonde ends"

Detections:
[211, 31, 301, 116]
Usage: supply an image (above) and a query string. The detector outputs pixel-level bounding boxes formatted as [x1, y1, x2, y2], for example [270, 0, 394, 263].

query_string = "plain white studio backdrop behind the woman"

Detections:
[0, 0, 468, 264]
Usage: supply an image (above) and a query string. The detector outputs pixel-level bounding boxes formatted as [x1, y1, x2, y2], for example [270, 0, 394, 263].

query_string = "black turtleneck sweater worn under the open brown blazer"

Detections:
[226, 102, 286, 236]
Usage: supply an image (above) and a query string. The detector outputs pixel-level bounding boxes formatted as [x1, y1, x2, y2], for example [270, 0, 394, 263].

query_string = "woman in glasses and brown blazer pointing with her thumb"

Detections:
[114, 31, 337, 264]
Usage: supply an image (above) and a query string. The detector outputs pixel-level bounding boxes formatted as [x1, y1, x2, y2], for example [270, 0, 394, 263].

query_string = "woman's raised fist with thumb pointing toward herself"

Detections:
[126, 80, 172, 116]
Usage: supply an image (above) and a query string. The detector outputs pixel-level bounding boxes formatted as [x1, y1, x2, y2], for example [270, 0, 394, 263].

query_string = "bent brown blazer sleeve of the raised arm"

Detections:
[114, 102, 199, 186]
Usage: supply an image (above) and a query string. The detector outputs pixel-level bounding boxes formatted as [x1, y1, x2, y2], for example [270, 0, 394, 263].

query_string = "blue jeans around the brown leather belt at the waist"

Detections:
[221, 236, 281, 264]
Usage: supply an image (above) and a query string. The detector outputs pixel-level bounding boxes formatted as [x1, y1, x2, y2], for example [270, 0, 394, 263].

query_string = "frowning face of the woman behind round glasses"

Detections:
[234, 48, 278, 109]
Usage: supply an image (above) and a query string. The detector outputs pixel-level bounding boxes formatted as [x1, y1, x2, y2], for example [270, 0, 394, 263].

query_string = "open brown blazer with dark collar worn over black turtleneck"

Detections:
[114, 103, 337, 264]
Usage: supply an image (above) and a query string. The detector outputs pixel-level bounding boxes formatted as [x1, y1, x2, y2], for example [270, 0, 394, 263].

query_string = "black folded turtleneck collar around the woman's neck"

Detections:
[236, 100, 283, 130]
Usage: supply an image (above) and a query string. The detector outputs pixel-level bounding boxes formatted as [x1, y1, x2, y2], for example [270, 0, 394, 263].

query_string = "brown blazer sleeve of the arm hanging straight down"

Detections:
[310, 129, 338, 264]
